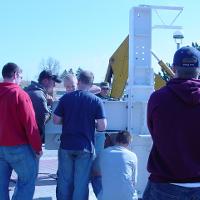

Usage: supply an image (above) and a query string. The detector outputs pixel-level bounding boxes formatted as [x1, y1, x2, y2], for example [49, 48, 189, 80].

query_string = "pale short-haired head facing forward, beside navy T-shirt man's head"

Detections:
[63, 74, 78, 92]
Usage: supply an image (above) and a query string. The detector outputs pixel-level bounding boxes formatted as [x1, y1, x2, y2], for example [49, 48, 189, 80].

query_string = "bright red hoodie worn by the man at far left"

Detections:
[0, 83, 42, 153]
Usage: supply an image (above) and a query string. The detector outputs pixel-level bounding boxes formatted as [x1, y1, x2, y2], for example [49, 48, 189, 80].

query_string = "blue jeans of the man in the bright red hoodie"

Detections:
[0, 145, 38, 200]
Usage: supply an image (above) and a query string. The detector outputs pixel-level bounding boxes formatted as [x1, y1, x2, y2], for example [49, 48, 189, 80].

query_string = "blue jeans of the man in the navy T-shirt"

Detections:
[56, 148, 93, 200]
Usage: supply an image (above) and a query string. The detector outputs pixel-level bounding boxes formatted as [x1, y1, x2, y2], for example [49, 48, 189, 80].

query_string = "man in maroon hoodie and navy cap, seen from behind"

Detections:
[143, 46, 200, 200]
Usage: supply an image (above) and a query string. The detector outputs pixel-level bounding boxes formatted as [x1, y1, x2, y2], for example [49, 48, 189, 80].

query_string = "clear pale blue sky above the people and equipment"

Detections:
[0, 0, 200, 82]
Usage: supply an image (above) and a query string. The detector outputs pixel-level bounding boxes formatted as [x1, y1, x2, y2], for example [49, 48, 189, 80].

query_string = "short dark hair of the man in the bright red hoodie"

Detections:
[2, 63, 22, 78]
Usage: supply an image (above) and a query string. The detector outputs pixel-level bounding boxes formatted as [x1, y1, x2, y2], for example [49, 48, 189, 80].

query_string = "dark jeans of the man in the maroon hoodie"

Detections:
[143, 181, 200, 200]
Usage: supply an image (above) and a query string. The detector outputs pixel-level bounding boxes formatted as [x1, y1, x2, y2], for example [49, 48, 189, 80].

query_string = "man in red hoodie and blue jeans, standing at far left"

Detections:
[0, 63, 42, 200]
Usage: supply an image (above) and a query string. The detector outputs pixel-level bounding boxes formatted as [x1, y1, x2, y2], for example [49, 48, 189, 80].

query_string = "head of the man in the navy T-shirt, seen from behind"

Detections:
[78, 70, 94, 90]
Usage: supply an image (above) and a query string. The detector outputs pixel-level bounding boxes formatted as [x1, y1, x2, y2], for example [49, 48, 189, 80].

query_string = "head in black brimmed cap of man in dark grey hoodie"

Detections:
[38, 70, 61, 94]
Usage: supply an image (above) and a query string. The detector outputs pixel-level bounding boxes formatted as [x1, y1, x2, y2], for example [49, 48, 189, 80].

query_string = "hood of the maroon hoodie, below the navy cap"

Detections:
[167, 78, 200, 105]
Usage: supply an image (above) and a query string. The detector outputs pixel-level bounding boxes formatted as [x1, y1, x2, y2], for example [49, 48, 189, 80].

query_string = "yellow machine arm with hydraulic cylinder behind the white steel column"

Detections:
[105, 36, 174, 99]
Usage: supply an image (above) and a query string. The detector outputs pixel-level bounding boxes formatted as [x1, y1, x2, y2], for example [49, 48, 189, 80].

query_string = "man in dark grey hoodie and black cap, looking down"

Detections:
[25, 70, 61, 143]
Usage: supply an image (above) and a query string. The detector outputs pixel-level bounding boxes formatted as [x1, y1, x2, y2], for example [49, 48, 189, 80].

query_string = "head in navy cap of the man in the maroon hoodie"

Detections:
[173, 46, 200, 79]
